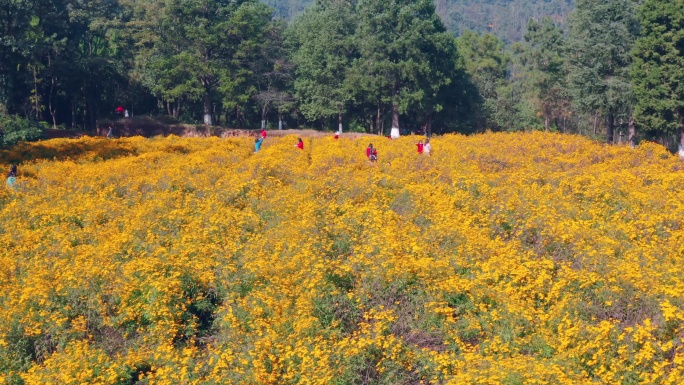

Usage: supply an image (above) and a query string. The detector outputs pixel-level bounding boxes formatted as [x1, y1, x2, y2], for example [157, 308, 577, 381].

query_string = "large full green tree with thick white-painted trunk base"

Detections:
[355, 0, 455, 137]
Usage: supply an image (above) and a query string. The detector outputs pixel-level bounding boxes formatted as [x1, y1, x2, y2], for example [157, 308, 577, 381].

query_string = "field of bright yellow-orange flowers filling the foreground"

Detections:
[0, 133, 684, 385]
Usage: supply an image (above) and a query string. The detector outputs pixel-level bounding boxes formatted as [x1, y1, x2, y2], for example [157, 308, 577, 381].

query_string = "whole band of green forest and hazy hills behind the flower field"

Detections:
[0, 0, 684, 148]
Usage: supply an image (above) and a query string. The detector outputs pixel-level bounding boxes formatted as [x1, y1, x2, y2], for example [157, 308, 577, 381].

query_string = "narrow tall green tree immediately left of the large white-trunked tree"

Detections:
[289, 0, 358, 132]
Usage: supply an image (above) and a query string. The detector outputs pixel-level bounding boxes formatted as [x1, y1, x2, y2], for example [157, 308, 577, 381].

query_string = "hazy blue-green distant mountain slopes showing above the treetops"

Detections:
[262, 0, 574, 42]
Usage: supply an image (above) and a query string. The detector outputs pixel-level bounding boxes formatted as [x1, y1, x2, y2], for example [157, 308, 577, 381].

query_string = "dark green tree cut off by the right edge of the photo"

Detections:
[631, 0, 684, 152]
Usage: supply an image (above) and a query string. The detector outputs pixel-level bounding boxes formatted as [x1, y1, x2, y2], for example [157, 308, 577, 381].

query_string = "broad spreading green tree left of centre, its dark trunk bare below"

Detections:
[131, 0, 272, 125]
